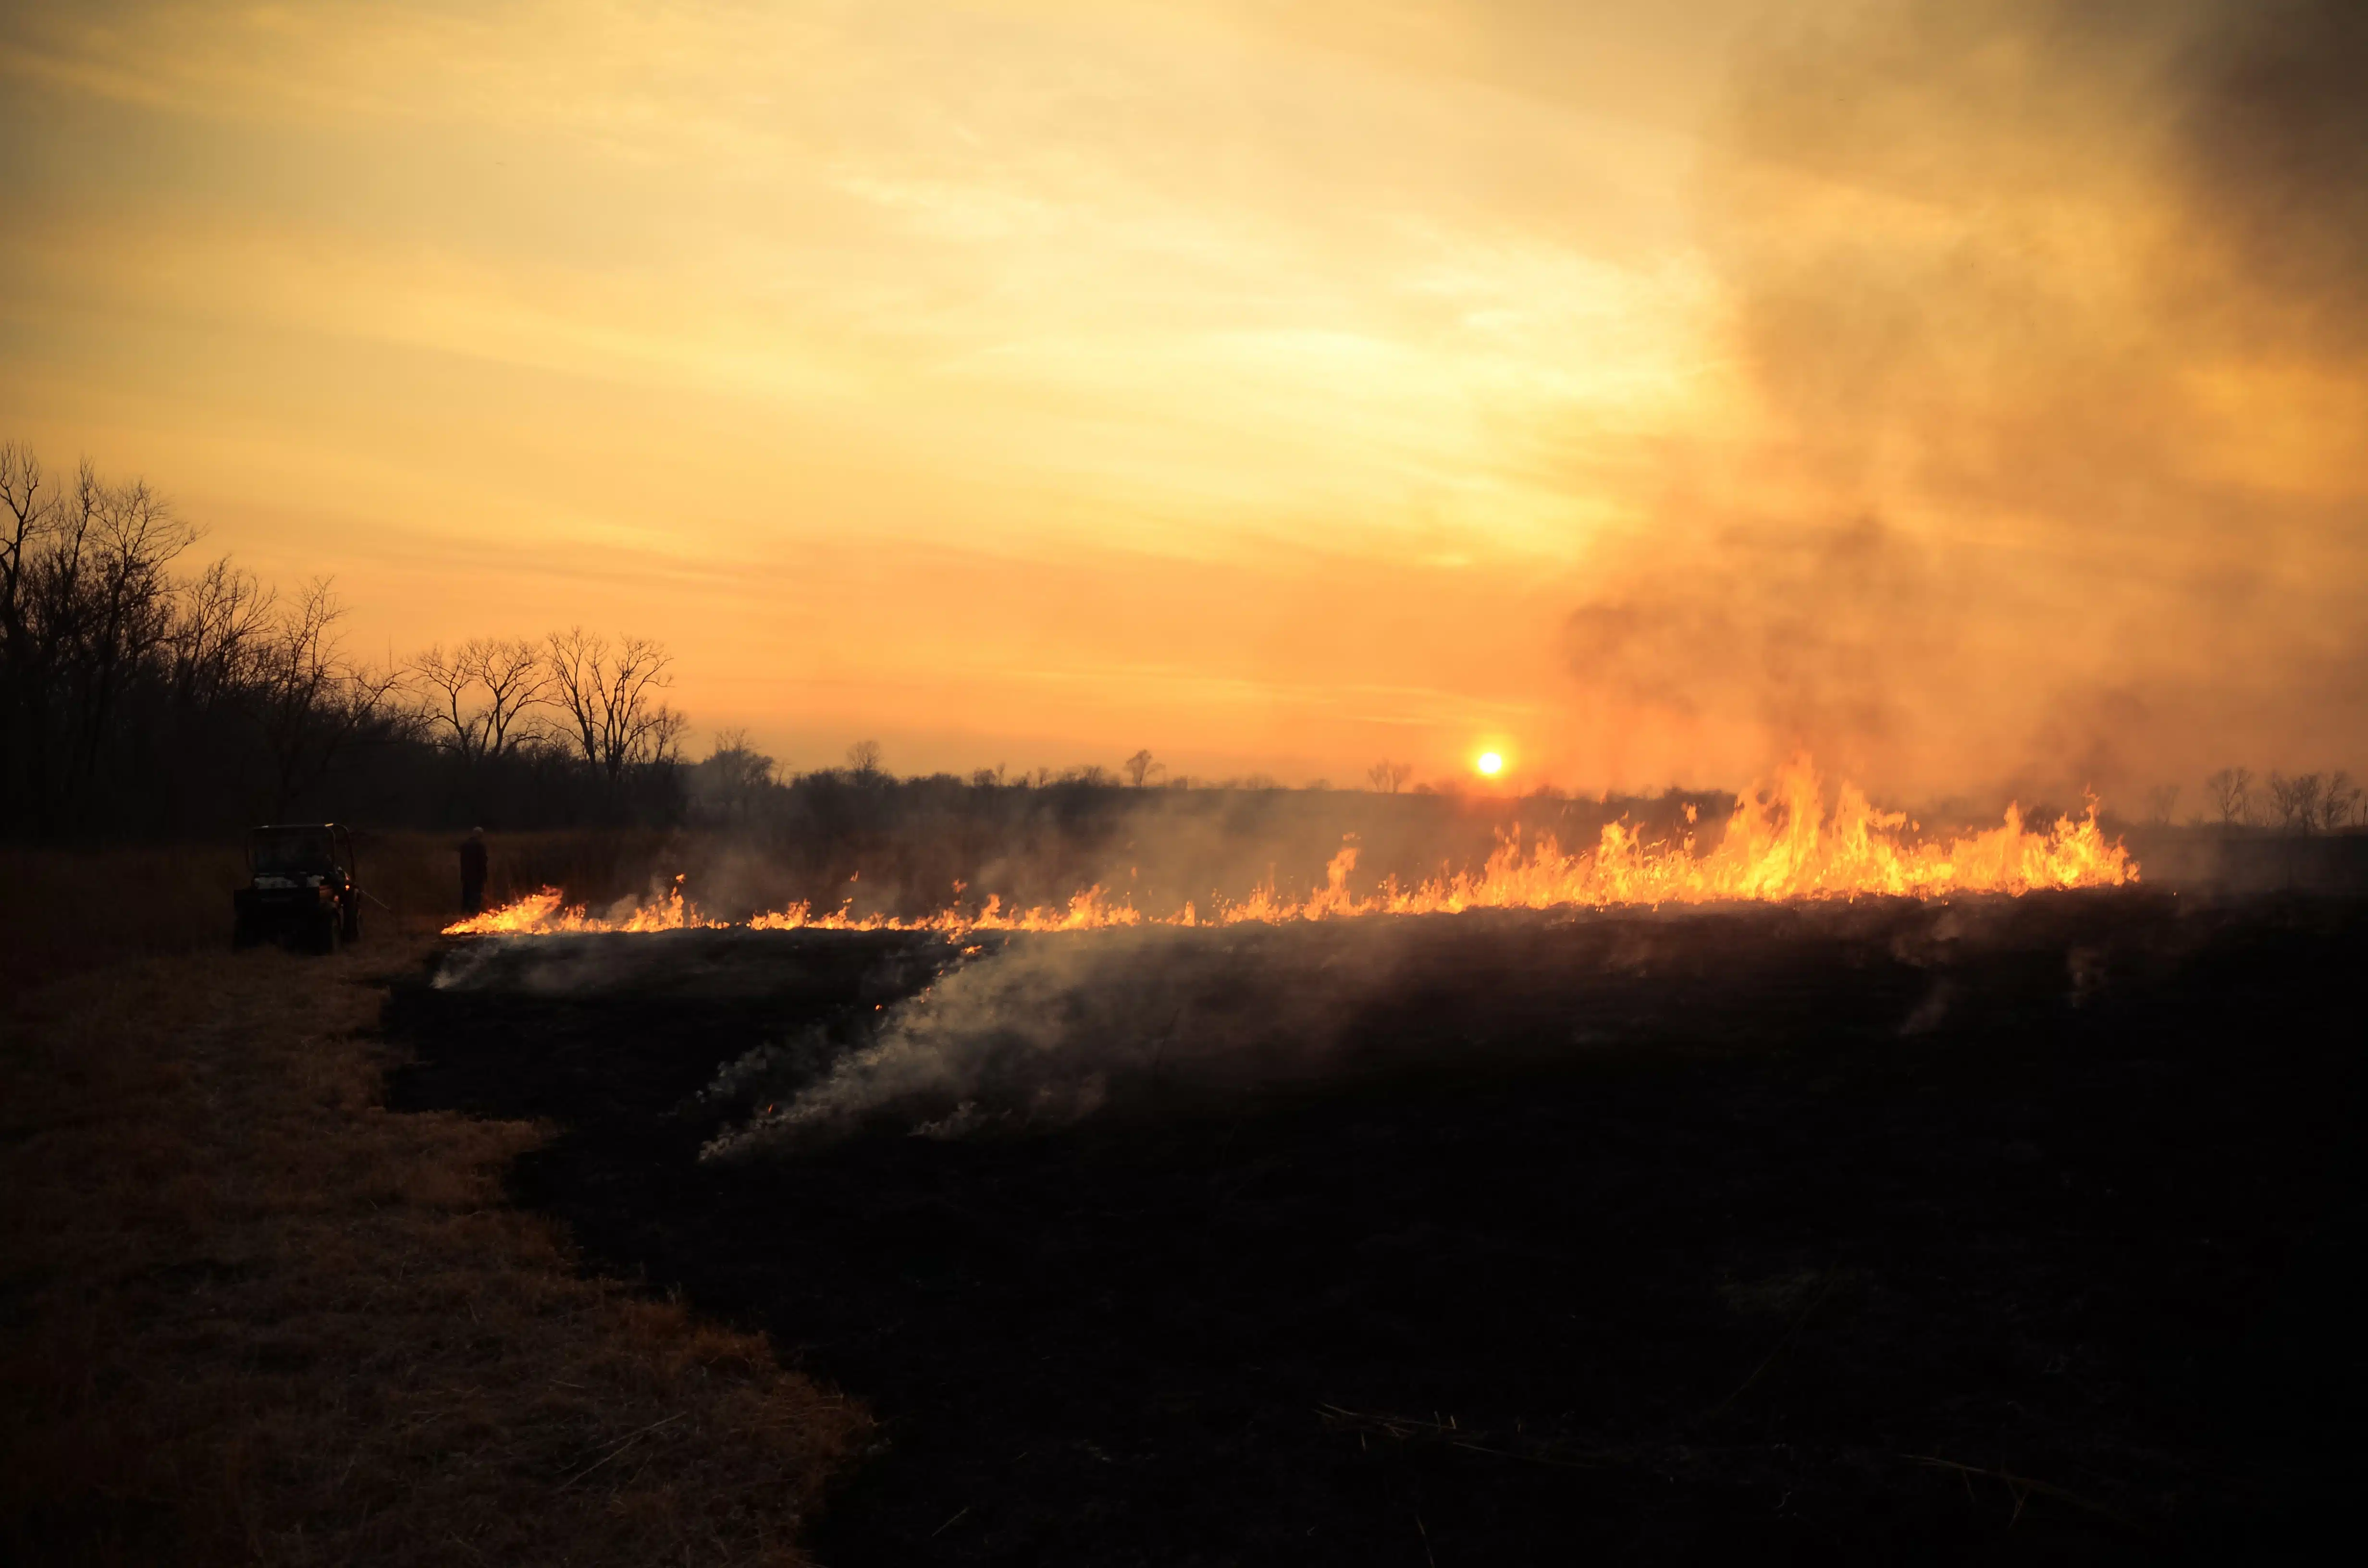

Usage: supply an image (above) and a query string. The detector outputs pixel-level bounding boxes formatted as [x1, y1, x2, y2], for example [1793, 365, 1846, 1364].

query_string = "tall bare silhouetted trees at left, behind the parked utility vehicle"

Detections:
[0, 445, 682, 841]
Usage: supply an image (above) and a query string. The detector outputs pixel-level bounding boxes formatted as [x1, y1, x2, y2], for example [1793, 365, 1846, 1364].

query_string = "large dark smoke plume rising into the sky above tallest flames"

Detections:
[1567, 0, 2368, 798]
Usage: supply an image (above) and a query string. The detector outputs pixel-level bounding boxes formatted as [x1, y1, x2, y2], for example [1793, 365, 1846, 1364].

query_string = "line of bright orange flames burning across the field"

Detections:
[447, 758, 2138, 936]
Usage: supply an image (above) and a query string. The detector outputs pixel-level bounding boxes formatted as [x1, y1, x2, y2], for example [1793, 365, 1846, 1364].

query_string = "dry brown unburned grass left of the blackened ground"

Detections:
[0, 862, 867, 1563]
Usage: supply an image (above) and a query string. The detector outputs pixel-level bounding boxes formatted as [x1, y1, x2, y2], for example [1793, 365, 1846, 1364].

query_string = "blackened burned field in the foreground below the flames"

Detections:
[386, 891, 2368, 1566]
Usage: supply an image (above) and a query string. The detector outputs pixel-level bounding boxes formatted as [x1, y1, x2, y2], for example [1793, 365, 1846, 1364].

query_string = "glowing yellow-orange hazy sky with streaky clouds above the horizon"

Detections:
[0, 0, 2368, 805]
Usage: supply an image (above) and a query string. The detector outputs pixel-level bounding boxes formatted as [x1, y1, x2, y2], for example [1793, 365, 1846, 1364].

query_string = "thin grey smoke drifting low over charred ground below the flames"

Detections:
[672, 891, 2159, 1158]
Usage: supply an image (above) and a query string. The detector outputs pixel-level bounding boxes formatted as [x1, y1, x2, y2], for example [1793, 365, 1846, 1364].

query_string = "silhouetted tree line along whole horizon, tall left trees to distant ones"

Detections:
[0, 443, 1961, 862]
